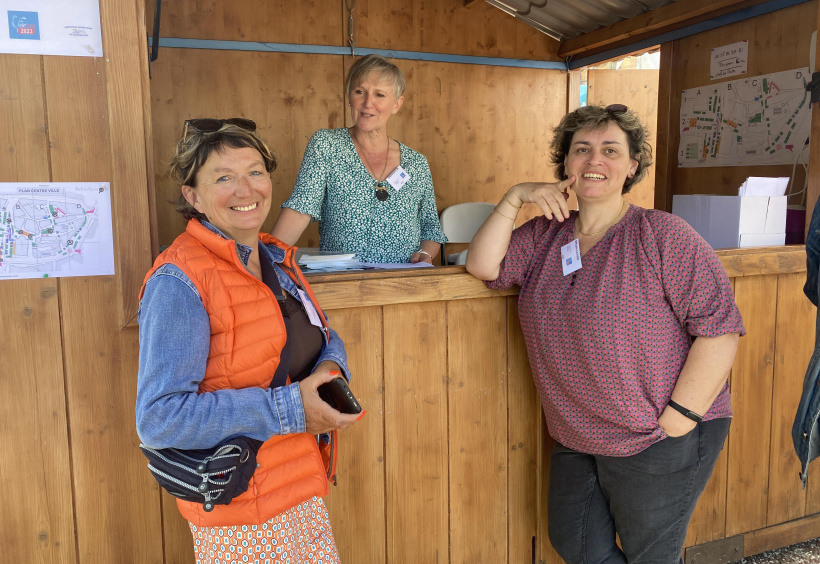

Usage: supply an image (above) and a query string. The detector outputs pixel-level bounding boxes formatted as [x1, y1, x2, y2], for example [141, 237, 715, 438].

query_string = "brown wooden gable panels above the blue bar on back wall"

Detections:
[155, 0, 559, 61]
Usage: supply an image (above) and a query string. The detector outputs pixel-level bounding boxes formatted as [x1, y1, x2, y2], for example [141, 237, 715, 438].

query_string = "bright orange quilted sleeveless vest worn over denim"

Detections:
[140, 219, 337, 527]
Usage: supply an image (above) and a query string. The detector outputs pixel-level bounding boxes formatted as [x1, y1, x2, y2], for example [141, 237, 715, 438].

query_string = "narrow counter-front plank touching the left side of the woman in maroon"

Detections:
[506, 296, 541, 562]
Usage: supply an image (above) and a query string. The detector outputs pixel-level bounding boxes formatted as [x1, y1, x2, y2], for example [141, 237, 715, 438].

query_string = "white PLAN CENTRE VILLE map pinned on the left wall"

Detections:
[0, 182, 114, 280]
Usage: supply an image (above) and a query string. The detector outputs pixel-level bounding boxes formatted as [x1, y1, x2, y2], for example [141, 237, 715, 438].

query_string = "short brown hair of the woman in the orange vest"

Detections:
[169, 121, 276, 220]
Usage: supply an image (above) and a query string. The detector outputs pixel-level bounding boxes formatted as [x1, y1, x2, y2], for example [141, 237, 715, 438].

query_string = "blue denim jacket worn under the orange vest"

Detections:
[136, 221, 350, 449]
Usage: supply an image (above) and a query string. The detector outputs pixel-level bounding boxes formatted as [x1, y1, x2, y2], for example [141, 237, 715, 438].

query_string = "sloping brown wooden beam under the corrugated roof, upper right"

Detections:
[560, 0, 767, 59]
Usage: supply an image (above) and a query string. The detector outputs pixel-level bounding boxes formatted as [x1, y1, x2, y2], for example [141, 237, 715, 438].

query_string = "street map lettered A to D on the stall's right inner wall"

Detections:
[678, 68, 811, 167]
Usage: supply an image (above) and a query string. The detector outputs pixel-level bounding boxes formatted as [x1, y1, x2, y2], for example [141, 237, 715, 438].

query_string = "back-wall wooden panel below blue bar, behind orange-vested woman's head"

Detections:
[146, 49, 346, 247]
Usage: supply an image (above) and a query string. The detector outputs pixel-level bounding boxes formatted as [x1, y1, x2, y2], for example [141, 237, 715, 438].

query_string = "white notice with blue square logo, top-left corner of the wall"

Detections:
[0, 0, 103, 57]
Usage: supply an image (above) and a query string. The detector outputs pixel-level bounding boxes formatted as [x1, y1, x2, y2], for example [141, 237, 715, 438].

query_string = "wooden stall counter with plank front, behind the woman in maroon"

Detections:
[302, 246, 820, 564]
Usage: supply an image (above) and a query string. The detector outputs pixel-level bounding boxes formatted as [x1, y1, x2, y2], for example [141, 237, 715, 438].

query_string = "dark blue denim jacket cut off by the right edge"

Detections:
[792, 200, 820, 488]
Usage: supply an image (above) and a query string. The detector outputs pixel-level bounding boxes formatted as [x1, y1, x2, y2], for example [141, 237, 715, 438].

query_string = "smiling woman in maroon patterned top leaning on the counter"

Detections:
[467, 105, 744, 564]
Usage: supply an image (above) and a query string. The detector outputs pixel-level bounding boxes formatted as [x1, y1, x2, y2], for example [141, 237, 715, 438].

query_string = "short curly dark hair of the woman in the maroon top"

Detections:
[550, 104, 652, 194]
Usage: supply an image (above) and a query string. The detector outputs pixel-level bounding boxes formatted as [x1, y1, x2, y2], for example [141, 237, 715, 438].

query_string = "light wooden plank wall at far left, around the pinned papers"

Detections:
[0, 0, 156, 564]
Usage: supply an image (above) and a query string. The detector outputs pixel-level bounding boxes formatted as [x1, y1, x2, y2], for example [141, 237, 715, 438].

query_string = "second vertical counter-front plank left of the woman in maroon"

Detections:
[447, 298, 510, 564]
